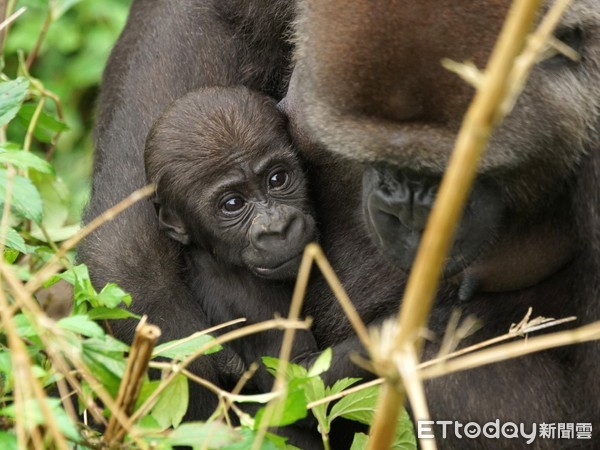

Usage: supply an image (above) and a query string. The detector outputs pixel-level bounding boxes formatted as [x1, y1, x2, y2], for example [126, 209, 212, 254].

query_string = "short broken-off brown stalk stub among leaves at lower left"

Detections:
[104, 317, 160, 446]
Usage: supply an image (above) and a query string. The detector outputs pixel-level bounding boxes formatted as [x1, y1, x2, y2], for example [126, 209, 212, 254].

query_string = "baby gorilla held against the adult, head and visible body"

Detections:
[145, 87, 317, 391]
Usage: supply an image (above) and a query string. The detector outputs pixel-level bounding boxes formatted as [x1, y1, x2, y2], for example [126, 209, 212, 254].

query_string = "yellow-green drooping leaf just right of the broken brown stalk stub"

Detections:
[151, 374, 189, 429]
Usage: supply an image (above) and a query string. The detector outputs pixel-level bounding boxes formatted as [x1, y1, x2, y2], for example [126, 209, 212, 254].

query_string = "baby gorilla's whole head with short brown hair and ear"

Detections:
[145, 87, 316, 279]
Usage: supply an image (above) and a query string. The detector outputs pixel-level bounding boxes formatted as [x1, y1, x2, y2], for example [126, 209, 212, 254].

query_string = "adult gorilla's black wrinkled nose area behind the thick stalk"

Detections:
[363, 165, 505, 278]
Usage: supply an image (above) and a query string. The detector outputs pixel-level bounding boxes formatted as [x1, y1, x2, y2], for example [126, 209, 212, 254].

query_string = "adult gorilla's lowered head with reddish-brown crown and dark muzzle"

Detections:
[286, 0, 600, 290]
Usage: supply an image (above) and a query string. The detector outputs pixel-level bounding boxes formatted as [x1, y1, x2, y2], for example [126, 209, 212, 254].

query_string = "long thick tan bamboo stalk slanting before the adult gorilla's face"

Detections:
[368, 0, 541, 450]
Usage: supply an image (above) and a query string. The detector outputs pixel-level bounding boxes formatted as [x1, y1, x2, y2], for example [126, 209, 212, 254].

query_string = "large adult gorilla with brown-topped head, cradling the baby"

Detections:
[81, 0, 600, 449]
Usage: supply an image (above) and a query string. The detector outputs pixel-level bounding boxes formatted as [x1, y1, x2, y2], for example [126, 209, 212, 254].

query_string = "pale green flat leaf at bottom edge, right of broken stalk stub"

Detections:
[165, 422, 241, 449]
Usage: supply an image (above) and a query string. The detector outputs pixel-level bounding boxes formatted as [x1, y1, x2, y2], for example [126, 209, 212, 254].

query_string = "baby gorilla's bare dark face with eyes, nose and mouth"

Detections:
[203, 148, 316, 279]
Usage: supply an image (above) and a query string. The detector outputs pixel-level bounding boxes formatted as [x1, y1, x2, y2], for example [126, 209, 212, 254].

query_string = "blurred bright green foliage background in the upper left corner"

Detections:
[4, 0, 131, 223]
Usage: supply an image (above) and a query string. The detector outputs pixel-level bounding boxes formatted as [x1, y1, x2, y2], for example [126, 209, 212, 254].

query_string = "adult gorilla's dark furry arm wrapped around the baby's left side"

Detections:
[79, 0, 290, 414]
